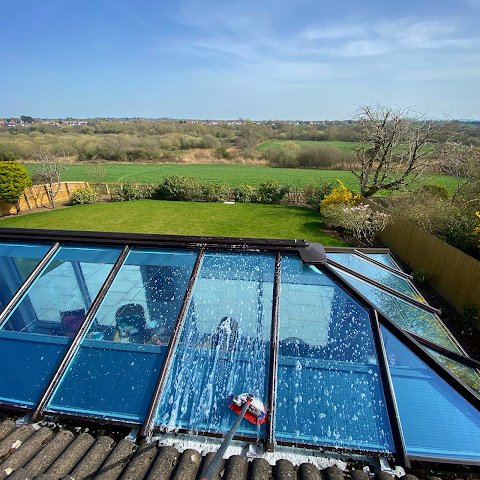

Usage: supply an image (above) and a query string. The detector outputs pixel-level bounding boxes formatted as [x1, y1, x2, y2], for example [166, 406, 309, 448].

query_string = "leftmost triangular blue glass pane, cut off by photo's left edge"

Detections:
[0, 242, 51, 311]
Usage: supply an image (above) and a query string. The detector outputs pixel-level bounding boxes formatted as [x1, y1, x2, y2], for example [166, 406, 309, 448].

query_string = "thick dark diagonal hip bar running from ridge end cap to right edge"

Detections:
[318, 265, 480, 411]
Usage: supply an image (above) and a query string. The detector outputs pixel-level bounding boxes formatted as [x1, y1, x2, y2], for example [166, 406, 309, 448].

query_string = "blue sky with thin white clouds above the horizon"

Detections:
[0, 0, 480, 120]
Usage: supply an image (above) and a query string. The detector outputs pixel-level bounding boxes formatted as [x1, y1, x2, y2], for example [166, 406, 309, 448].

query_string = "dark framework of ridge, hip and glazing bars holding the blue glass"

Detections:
[0, 228, 480, 466]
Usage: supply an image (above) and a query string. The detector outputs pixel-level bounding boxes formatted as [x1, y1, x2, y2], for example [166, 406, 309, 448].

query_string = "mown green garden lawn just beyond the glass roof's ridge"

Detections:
[0, 200, 347, 246]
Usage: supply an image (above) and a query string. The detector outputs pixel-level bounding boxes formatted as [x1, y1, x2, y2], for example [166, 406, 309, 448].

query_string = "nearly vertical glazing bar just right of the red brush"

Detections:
[264, 252, 282, 452]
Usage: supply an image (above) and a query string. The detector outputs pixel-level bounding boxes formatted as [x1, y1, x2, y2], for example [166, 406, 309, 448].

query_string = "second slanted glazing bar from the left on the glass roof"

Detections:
[29, 245, 130, 422]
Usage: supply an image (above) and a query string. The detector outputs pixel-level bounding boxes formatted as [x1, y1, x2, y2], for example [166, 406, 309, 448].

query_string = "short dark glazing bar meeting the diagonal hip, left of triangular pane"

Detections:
[369, 308, 410, 468]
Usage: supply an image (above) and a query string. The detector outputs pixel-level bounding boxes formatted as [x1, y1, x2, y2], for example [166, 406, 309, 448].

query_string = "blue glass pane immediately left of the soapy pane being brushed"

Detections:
[47, 249, 198, 422]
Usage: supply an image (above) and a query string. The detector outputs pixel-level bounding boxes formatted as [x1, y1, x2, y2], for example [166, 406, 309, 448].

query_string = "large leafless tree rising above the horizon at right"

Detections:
[352, 104, 440, 197]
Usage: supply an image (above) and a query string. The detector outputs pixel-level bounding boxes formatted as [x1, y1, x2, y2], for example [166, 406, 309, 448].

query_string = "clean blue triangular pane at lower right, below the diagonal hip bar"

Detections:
[382, 326, 480, 460]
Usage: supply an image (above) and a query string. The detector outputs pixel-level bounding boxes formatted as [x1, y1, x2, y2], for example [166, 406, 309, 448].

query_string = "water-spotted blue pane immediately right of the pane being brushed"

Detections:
[275, 255, 394, 451]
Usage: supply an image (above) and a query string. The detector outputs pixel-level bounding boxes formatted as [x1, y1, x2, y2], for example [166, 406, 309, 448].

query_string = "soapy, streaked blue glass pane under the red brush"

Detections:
[156, 253, 275, 436]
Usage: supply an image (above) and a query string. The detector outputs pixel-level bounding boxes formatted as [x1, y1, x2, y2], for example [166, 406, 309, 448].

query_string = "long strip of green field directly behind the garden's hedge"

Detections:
[20, 163, 455, 194]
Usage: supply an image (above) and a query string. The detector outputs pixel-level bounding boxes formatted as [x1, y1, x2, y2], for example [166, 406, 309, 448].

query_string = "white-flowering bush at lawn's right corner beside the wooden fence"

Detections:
[322, 203, 392, 246]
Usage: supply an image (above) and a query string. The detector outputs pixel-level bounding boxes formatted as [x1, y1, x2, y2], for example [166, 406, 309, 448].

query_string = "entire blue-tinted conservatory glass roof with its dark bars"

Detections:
[0, 228, 480, 465]
